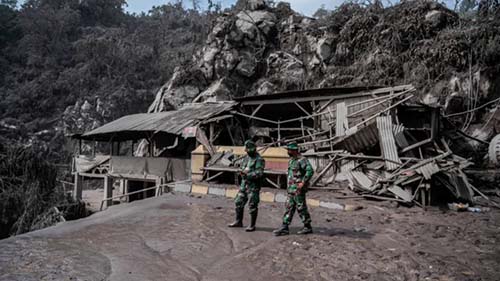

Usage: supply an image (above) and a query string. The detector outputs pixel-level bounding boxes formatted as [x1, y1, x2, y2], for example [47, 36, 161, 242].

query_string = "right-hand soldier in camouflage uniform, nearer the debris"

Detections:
[273, 143, 314, 236]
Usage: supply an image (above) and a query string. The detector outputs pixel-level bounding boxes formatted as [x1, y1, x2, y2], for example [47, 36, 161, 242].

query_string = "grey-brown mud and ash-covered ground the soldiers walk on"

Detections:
[0, 194, 500, 281]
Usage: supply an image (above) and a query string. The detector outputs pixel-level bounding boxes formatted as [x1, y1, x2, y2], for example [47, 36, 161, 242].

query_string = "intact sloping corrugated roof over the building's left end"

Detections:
[81, 102, 236, 140]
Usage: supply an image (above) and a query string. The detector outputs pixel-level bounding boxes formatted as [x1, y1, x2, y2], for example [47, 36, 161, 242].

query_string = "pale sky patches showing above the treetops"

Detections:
[125, 0, 342, 16]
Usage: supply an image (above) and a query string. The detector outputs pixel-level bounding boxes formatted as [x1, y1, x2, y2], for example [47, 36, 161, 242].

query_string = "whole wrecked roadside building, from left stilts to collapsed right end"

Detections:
[73, 85, 500, 208]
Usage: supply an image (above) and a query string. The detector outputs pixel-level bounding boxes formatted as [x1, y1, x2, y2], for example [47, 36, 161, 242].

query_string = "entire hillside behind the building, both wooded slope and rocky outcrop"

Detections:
[0, 0, 500, 156]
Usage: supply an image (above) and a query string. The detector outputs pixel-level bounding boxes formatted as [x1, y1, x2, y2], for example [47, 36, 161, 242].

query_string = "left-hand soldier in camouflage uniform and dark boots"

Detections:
[228, 140, 265, 232]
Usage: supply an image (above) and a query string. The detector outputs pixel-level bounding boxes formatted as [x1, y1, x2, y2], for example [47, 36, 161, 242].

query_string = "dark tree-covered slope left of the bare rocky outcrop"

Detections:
[0, 0, 213, 160]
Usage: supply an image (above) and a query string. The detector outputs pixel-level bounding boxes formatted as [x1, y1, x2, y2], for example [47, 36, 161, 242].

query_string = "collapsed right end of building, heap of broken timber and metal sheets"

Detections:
[301, 88, 494, 207]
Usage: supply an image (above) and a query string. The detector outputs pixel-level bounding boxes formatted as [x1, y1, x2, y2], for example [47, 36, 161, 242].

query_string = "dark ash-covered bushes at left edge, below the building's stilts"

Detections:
[0, 144, 85, 238]
